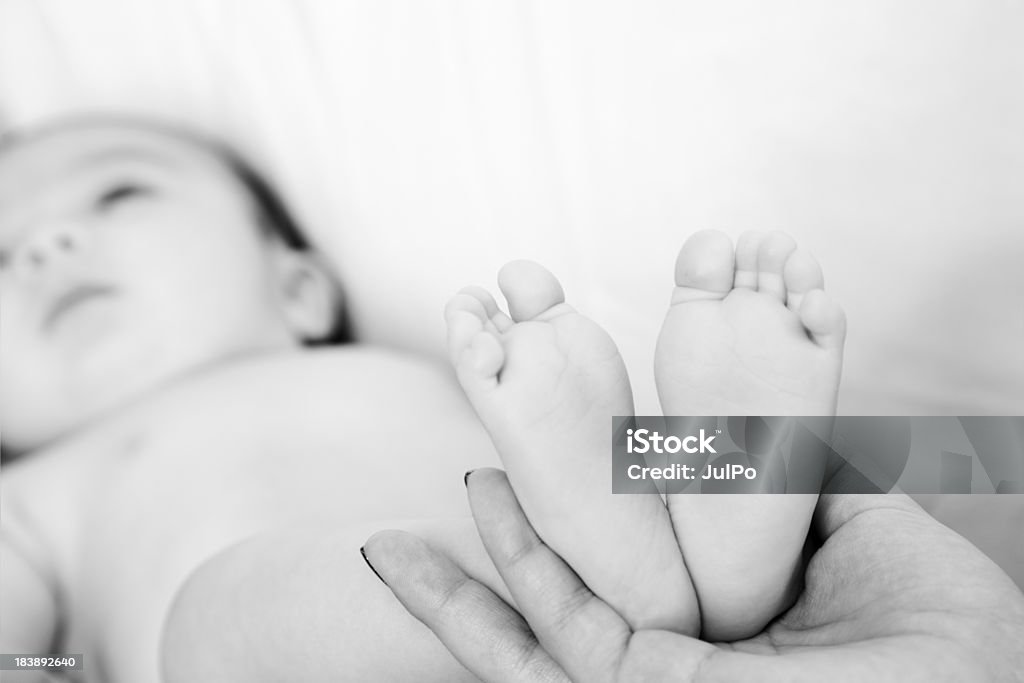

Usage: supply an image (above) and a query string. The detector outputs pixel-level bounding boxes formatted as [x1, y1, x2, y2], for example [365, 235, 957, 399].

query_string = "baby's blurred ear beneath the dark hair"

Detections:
[274, 248, 341, 342]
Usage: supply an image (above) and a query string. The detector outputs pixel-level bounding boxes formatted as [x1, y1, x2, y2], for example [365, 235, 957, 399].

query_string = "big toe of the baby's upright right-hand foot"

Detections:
[672, 230, 736, 303]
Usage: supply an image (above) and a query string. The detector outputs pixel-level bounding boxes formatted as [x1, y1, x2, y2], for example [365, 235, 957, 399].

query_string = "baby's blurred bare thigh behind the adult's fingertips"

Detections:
[162, 518, 509, 683]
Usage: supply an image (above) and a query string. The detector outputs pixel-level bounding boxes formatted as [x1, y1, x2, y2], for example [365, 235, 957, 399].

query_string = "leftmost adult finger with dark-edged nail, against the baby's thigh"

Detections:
[364, 531, 568, 683]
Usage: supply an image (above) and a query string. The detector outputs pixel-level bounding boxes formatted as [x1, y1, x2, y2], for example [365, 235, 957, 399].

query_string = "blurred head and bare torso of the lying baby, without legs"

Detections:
[0, 119, 496, 683]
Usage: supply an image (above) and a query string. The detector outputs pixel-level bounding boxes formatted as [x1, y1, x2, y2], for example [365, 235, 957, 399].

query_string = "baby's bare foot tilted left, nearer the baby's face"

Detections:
[445, 261, 698, 634]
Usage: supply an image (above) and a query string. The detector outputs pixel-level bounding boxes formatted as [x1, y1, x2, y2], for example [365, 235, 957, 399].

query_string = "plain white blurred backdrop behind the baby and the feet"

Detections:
[0, 0, 1024, 581]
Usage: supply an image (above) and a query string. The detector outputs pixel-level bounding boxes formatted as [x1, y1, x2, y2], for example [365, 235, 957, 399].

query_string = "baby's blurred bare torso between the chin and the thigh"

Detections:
[46, 351, 496, 683]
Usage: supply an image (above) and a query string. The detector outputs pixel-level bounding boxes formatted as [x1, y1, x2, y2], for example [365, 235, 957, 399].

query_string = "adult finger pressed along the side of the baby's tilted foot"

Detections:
[467, 469, 631, 682]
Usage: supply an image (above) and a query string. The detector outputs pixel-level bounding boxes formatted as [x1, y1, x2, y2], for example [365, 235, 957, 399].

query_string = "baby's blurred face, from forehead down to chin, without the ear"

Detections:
[0, 125, 296, 449]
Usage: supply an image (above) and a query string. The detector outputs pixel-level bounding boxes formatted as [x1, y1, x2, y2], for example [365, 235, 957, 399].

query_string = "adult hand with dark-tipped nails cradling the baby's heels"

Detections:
[366, 470, 1024, 683]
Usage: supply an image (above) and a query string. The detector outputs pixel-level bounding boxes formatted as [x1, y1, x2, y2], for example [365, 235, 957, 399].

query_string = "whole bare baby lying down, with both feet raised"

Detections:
[0, 121, 843, 683]
